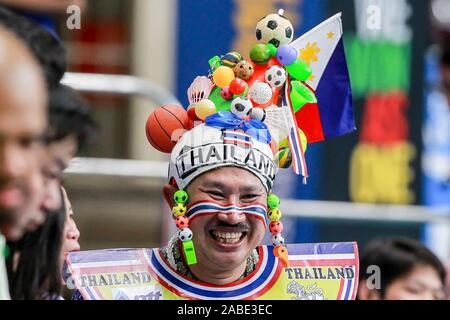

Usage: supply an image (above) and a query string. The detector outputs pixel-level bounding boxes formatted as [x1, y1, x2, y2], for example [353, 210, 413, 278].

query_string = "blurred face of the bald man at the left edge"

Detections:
[0, 50, 46, 238]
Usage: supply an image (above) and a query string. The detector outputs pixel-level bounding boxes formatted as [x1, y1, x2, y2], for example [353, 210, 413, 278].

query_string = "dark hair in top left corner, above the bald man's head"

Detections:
[0, 6, 67, 88]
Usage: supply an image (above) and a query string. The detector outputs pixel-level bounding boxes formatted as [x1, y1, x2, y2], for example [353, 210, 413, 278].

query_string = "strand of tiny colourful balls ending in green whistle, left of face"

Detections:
[172, 190, 197, 265]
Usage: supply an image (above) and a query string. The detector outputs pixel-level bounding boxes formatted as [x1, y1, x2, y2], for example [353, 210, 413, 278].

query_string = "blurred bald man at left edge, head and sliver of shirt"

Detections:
[0, 28, 47, 300]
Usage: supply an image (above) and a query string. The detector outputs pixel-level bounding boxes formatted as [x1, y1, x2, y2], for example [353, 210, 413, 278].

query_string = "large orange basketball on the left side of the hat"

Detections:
[145, 104, 193, 153]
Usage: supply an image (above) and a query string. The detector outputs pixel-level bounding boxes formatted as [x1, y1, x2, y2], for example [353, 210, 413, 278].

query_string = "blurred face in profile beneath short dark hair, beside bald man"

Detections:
[42, 136, 77, 212]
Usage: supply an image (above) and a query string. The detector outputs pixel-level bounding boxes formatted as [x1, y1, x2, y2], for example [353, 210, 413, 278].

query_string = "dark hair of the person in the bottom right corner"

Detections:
[359, 238, 446, 297]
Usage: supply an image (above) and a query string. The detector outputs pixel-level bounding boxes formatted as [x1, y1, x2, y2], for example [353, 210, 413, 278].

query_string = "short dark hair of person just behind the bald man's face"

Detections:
[46, 84, 97, 151]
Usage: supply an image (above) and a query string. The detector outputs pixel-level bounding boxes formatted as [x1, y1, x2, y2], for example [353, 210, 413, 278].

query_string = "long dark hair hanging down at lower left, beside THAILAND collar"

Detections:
[6, 191, 66, 300]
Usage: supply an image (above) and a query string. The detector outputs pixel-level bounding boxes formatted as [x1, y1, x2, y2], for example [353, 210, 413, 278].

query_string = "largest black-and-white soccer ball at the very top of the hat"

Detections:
[256, 13, 294, 48]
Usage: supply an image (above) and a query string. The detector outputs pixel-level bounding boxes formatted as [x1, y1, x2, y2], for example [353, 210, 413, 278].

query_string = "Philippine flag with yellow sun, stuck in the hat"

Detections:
[292, 13, 356, 143]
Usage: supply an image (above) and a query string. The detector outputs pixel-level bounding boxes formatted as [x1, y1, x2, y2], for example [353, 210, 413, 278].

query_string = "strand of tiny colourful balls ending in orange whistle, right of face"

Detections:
[267, 193, 289, 266]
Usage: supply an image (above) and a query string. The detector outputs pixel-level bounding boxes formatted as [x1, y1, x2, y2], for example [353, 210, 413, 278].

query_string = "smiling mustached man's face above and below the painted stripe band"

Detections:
[186, 167, 267, 280]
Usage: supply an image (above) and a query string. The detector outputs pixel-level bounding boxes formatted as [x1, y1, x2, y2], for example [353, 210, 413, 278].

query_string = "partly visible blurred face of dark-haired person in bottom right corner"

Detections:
[384, 265, 444, 300]
